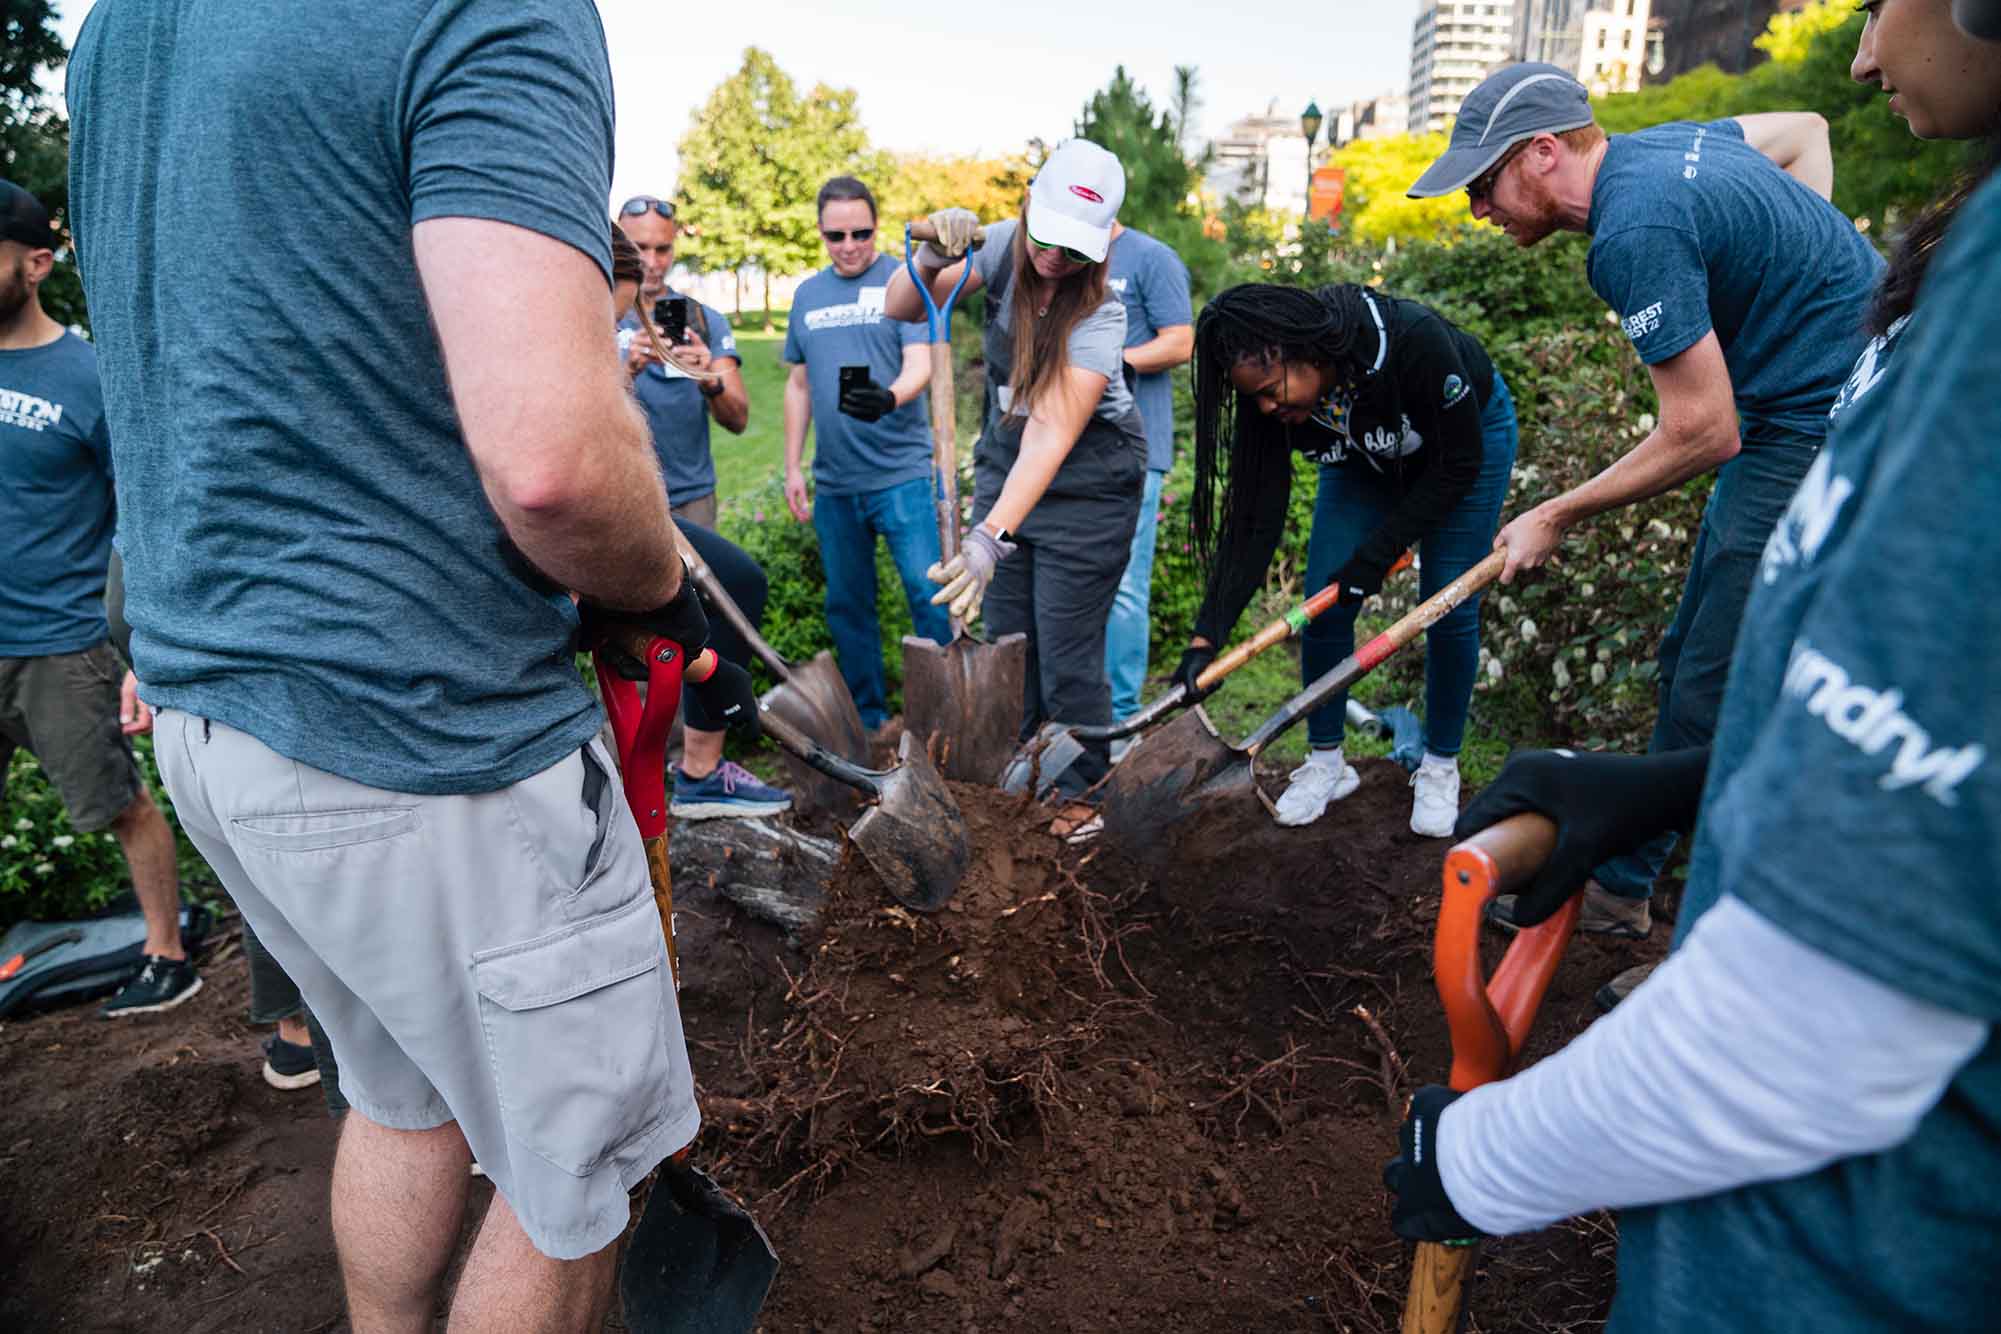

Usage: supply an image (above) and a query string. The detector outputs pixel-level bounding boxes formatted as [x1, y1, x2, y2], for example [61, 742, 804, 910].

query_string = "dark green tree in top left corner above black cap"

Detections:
[0, 0, 90, 328]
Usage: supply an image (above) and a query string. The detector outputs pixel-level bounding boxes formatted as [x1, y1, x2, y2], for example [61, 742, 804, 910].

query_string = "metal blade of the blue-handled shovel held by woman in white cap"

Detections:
[902, 634, 1029, 784]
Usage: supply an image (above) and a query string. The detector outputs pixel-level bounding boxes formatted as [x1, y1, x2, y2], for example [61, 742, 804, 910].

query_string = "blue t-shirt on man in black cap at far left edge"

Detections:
[0, 334, 116, 658]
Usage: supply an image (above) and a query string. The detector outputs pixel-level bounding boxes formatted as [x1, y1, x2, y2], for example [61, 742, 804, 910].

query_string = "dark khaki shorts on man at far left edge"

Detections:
[0, 640, 144, 834]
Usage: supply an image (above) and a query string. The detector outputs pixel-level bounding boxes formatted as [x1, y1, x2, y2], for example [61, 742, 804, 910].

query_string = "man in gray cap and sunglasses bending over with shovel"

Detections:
[1411, 64, 1883, 1000]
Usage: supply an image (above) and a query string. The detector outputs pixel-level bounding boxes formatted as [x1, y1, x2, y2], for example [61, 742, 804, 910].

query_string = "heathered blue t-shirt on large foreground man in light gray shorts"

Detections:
[68, 0, 612, 794]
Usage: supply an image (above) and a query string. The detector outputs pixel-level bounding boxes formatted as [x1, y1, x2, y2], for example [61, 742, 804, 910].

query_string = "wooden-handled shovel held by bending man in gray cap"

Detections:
[1103, 550, 1507, 850]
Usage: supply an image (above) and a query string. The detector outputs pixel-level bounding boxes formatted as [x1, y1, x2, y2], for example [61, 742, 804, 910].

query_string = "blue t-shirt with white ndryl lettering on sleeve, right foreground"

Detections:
[1611, 180, 2001, 1334]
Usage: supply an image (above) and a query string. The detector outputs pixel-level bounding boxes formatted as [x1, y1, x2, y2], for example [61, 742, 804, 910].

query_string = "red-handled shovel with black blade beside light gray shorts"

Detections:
[596, 640, 778, 1334]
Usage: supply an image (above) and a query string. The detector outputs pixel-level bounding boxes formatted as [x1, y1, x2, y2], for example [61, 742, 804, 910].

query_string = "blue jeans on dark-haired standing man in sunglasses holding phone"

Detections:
[812, 478, 952, 728]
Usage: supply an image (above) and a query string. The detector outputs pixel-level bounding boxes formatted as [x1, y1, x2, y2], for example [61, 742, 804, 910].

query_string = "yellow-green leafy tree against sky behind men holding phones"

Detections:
[678, 46, 884, 324]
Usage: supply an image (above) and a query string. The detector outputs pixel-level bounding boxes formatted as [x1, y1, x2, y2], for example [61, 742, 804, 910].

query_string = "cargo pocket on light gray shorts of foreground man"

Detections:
[472, 896, 672, 1176]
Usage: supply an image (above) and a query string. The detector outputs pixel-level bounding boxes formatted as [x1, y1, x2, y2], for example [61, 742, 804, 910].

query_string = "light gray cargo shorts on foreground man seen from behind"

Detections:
[154, 710, 700, 1260]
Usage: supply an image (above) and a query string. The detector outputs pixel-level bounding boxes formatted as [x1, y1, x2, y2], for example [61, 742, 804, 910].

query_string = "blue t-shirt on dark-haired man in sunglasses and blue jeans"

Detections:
[784, 254, 930, 496]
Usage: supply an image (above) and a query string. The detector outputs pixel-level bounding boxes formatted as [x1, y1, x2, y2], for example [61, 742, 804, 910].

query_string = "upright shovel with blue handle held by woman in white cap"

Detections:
[902, 220, 1029, 782]
